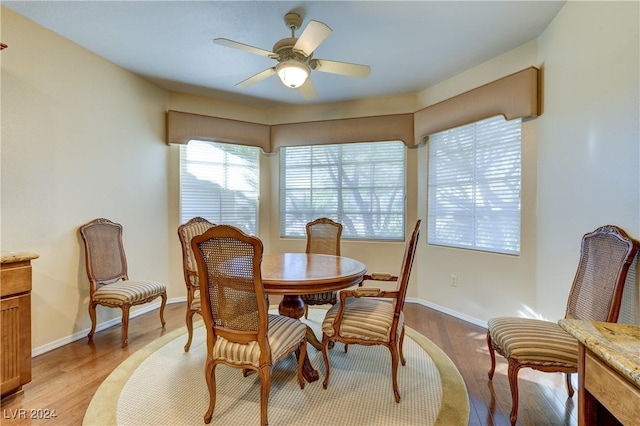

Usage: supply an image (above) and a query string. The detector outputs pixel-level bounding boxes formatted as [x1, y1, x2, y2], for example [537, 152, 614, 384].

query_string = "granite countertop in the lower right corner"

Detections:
[558, 319, 640, 388]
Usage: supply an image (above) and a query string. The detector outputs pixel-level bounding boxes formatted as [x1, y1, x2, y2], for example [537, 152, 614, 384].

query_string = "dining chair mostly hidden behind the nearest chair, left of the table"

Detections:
[178, 217, 214, 352]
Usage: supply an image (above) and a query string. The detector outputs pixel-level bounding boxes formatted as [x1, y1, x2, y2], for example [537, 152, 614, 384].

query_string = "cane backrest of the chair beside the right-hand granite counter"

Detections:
[565, 225, 638, 322]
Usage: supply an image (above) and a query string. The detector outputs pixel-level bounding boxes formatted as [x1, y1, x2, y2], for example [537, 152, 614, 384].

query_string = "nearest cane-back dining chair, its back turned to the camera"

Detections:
[191, 225, 307, 425]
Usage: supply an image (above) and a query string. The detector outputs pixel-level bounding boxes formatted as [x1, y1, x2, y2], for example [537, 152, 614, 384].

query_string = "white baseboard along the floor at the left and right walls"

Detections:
[31, 296, 487, 357]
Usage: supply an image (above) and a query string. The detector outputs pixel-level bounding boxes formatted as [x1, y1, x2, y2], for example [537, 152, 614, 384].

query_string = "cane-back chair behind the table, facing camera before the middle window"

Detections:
[300, 217, 342, 318]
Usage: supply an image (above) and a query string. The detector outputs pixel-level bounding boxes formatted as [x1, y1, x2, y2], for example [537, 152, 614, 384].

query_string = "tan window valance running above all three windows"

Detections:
[167, 67, 540, 153]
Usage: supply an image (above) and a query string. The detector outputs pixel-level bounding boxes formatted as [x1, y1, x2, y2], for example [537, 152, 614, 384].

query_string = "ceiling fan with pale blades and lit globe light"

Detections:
[213, 12, 371, 99]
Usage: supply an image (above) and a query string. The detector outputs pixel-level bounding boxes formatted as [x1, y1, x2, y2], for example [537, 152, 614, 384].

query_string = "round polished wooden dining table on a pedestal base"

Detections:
[260, 253, 367, 382]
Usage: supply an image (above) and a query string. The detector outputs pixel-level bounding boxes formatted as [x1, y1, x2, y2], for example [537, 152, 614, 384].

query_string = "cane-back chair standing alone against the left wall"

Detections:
[79, 218, 167, 348]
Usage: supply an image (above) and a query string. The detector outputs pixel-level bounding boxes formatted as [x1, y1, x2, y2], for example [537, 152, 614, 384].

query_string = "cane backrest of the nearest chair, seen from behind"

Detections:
[191, 225, 270, 348]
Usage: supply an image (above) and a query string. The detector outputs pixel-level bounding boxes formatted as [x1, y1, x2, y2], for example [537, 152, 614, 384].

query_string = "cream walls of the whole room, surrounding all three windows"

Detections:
[0, 2, 640, 350]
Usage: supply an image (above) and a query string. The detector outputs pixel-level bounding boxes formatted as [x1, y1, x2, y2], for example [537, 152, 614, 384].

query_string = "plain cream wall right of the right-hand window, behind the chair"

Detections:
[536, 1, 640, 315]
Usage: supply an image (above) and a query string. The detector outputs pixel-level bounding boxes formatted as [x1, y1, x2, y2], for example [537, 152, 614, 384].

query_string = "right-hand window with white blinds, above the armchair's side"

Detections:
[427, 116, 522, 254]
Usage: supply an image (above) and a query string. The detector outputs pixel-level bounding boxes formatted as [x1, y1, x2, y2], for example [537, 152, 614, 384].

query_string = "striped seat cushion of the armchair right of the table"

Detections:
[322, 297, 404, 342]
